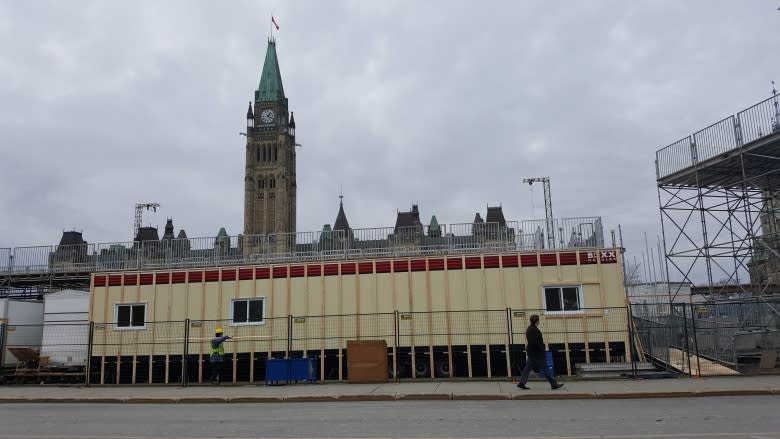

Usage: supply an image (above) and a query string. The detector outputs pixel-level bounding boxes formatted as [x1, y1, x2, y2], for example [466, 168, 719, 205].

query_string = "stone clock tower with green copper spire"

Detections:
[244, 39, 296, 248]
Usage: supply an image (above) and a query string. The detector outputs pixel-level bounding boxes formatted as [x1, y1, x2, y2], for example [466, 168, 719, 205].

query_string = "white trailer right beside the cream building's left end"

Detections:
[40, 290, 89, 367]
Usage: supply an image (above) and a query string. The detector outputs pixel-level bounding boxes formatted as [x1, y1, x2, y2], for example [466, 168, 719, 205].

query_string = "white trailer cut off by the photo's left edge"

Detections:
[0, 298, 43, 367]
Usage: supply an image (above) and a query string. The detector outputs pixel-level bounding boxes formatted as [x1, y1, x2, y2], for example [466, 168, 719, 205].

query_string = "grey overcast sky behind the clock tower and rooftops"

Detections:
[0, 0, 780, 282]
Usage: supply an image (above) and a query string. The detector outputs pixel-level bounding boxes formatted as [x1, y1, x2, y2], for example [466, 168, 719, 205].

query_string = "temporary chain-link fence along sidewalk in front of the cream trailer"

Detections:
[0, 308, 631, 385]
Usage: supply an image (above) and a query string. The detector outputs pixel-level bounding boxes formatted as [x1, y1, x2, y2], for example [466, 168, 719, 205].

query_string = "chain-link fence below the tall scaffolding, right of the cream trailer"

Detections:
[631, 299, 780, 376]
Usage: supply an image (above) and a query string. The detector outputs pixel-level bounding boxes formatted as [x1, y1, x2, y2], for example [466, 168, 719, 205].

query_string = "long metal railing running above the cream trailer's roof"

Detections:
[0, 217, 604, 274]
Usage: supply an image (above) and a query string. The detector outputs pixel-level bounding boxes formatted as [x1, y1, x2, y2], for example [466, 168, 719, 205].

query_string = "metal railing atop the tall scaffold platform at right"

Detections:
[655, 96, 780, 179]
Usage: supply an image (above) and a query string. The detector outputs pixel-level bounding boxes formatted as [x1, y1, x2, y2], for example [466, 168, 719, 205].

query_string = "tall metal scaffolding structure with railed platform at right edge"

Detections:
[655, 90, 780, 302]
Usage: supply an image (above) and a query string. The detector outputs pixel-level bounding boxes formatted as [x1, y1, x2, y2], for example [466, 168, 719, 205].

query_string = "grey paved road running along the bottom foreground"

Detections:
[0, 396, 780, 439]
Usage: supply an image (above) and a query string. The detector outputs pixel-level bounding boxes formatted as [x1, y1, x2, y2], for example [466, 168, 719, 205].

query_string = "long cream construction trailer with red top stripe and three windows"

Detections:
[89, 248, 630, 384]
